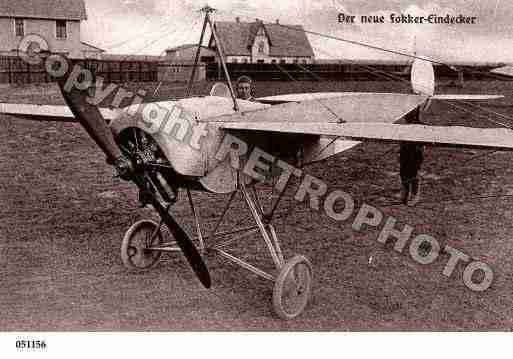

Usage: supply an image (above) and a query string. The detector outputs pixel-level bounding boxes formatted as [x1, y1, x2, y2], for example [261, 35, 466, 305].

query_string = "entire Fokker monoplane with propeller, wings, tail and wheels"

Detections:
[0, 7, 513, 319]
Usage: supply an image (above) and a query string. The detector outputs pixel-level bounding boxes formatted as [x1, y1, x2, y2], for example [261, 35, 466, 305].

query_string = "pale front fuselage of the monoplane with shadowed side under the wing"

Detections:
[110, 96, 336, 193]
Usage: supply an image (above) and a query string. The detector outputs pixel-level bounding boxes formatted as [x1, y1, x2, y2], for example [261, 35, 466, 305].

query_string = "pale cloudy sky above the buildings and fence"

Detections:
[82, 0, 513, 63]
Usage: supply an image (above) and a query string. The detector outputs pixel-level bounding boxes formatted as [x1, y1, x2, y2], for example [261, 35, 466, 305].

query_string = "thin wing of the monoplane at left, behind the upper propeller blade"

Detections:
[0, 103, 121, 122]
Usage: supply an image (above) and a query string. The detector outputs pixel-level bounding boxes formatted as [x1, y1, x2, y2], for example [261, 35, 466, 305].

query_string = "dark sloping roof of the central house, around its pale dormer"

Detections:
[211, 21, 314, 57]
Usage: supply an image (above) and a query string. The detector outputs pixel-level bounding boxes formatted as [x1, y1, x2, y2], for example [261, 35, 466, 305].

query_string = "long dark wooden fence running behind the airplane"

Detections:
[0, 56, 504, 84]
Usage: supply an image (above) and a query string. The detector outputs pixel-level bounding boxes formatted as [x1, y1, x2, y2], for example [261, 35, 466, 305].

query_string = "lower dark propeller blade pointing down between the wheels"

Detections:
[143, 183, 212, 289]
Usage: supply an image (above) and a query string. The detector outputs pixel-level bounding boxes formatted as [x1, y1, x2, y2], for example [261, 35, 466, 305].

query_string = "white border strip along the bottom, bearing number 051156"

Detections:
[0, 332, 511, 359]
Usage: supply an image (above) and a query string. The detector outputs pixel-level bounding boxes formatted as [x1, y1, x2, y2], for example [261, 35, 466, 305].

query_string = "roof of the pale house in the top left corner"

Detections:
[0, 0, 87, 20]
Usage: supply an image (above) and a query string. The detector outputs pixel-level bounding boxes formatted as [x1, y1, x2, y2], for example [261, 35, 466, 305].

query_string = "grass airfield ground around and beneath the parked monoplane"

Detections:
[0, 82, 513, 331]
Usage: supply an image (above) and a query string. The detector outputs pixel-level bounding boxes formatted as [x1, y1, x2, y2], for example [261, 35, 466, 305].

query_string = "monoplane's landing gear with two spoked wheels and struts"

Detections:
[121, 172, 313, 319]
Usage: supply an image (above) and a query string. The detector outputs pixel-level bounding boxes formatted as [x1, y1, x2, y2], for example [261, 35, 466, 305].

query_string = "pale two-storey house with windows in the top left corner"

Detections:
[0, 0, 103, 58]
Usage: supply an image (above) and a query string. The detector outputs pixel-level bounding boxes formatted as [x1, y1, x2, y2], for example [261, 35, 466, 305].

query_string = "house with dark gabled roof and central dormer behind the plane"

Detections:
[209, 18, 315, 63]
